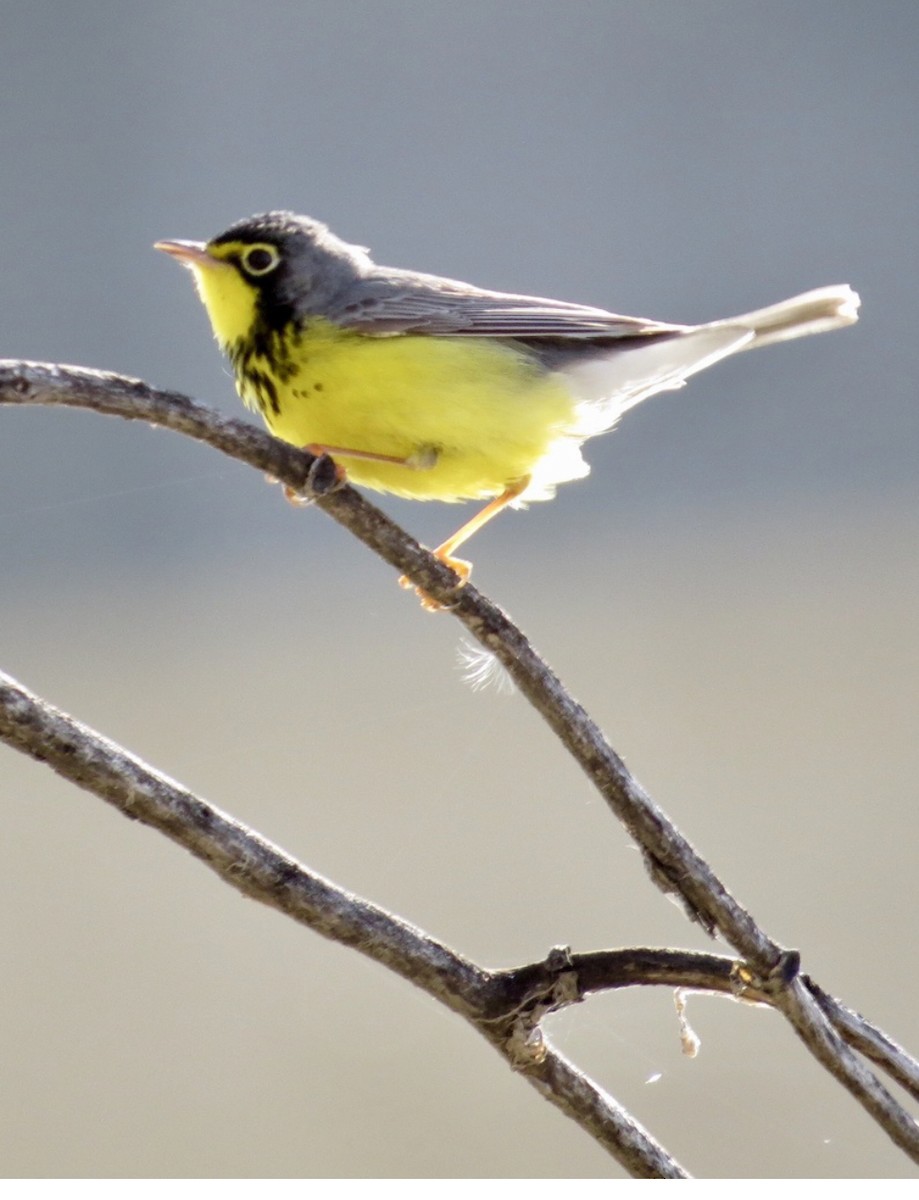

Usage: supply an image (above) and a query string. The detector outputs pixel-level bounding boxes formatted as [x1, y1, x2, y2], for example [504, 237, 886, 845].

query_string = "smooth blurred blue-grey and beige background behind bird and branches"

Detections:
[0, 0, 919, 1176]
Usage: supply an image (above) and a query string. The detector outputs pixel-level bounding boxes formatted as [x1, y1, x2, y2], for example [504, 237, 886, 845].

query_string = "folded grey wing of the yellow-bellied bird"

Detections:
[325, 269, 687, 340]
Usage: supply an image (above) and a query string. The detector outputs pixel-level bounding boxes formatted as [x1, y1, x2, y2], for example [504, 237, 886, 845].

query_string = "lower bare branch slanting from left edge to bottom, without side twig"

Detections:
[0, 673, 685, 1178]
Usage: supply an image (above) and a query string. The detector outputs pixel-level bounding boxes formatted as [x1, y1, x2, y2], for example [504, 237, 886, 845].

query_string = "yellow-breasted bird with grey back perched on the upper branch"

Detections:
[155, 211, 859, 608]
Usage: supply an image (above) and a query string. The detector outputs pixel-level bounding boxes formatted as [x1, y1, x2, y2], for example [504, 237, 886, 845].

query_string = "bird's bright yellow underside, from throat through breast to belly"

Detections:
[192, 244, 587, 500]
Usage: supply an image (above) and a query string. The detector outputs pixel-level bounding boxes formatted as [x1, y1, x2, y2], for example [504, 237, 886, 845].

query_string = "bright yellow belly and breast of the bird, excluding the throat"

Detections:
[251, 328, 583, 500]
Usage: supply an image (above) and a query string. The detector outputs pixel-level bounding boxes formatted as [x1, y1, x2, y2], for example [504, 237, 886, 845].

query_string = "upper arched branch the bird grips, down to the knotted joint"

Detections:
[0, 361, 782, 960]
